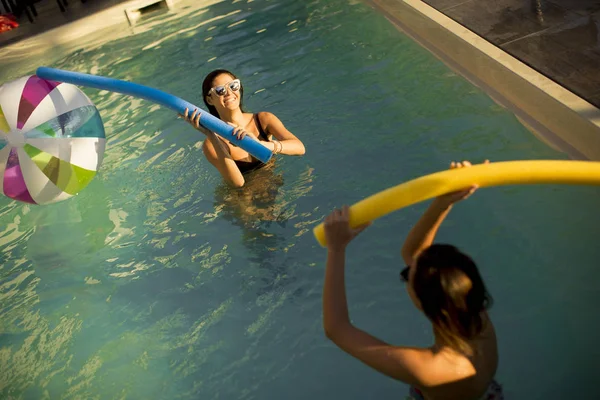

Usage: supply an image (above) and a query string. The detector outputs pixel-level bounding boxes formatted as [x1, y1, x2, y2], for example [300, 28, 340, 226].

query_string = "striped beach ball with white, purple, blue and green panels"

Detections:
[0, 75, 106, 204]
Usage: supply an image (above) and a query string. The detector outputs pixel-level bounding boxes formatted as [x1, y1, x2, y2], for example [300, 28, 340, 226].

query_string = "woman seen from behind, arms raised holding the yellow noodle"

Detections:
[323, 161, 503, 400]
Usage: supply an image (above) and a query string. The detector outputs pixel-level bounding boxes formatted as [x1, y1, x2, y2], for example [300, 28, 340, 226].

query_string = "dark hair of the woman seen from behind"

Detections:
[412, 244, 493, 355]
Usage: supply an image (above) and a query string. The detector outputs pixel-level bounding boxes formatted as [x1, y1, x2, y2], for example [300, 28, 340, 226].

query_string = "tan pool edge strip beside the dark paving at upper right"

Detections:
[363, 0, 600, 160]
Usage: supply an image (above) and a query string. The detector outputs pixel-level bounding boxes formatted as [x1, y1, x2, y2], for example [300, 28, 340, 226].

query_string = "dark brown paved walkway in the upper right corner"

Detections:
[424, 0, 600, 108]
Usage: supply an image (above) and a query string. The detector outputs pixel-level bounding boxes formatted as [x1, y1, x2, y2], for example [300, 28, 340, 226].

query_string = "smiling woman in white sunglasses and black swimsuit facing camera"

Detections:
[182, 69, 305, 187]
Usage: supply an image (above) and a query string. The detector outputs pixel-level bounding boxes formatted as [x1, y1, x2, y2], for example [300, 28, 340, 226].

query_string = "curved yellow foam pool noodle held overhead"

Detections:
[313, 160, 600, 247]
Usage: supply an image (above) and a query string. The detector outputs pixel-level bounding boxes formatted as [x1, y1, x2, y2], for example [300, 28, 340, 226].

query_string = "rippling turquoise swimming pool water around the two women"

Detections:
[0, 0, 600, 399]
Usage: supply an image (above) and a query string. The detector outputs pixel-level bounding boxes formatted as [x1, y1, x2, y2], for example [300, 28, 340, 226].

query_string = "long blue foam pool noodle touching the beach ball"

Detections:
[35, 67, 273, 163]
